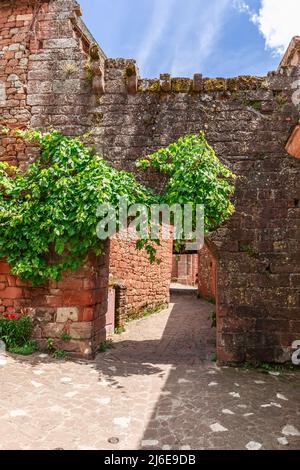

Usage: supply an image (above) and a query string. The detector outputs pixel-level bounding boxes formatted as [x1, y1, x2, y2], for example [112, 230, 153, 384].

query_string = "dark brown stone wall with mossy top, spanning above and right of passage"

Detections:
[94, 60, 300, 362]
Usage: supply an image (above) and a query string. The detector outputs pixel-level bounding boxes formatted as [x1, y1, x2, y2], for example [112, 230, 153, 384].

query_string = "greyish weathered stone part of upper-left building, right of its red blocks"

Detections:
[27, 0, 104, 135]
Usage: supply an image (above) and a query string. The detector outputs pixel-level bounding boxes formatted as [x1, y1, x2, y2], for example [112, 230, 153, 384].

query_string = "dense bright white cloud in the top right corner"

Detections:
[234, 0, 300, 54]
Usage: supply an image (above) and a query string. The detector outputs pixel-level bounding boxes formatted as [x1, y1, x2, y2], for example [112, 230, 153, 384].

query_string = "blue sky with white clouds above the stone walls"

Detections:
[79, 0, 300, 78]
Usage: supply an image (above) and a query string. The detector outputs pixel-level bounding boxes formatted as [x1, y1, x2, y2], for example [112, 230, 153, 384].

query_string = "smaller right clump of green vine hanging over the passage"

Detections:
[137, 132, 236, 232]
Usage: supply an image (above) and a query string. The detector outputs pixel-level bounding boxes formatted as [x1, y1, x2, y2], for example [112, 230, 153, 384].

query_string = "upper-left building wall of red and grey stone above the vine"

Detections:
[0, 0, 100, 166]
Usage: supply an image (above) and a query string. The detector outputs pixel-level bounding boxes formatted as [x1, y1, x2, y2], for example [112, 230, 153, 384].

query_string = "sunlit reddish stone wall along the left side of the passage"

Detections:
[109, 231, 173, 316]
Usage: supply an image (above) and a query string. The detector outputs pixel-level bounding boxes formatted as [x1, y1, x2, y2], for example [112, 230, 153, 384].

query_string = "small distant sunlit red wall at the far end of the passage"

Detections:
[172, 254, 198, 286]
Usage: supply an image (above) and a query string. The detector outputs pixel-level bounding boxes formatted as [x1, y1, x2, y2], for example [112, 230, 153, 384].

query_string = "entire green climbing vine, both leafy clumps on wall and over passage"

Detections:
[0, 130, 234, 284]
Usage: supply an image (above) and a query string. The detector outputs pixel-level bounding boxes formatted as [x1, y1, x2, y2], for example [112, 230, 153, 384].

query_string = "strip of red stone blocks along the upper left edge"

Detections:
[0, 0, 41, 164]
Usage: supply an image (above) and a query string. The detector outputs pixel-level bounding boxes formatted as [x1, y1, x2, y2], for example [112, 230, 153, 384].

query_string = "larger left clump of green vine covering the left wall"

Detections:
[0, 131, 157, 284]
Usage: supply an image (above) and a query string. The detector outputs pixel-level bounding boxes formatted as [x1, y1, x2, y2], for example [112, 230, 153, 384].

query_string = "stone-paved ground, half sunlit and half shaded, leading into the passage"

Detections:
[0, 294, 300, 450]
